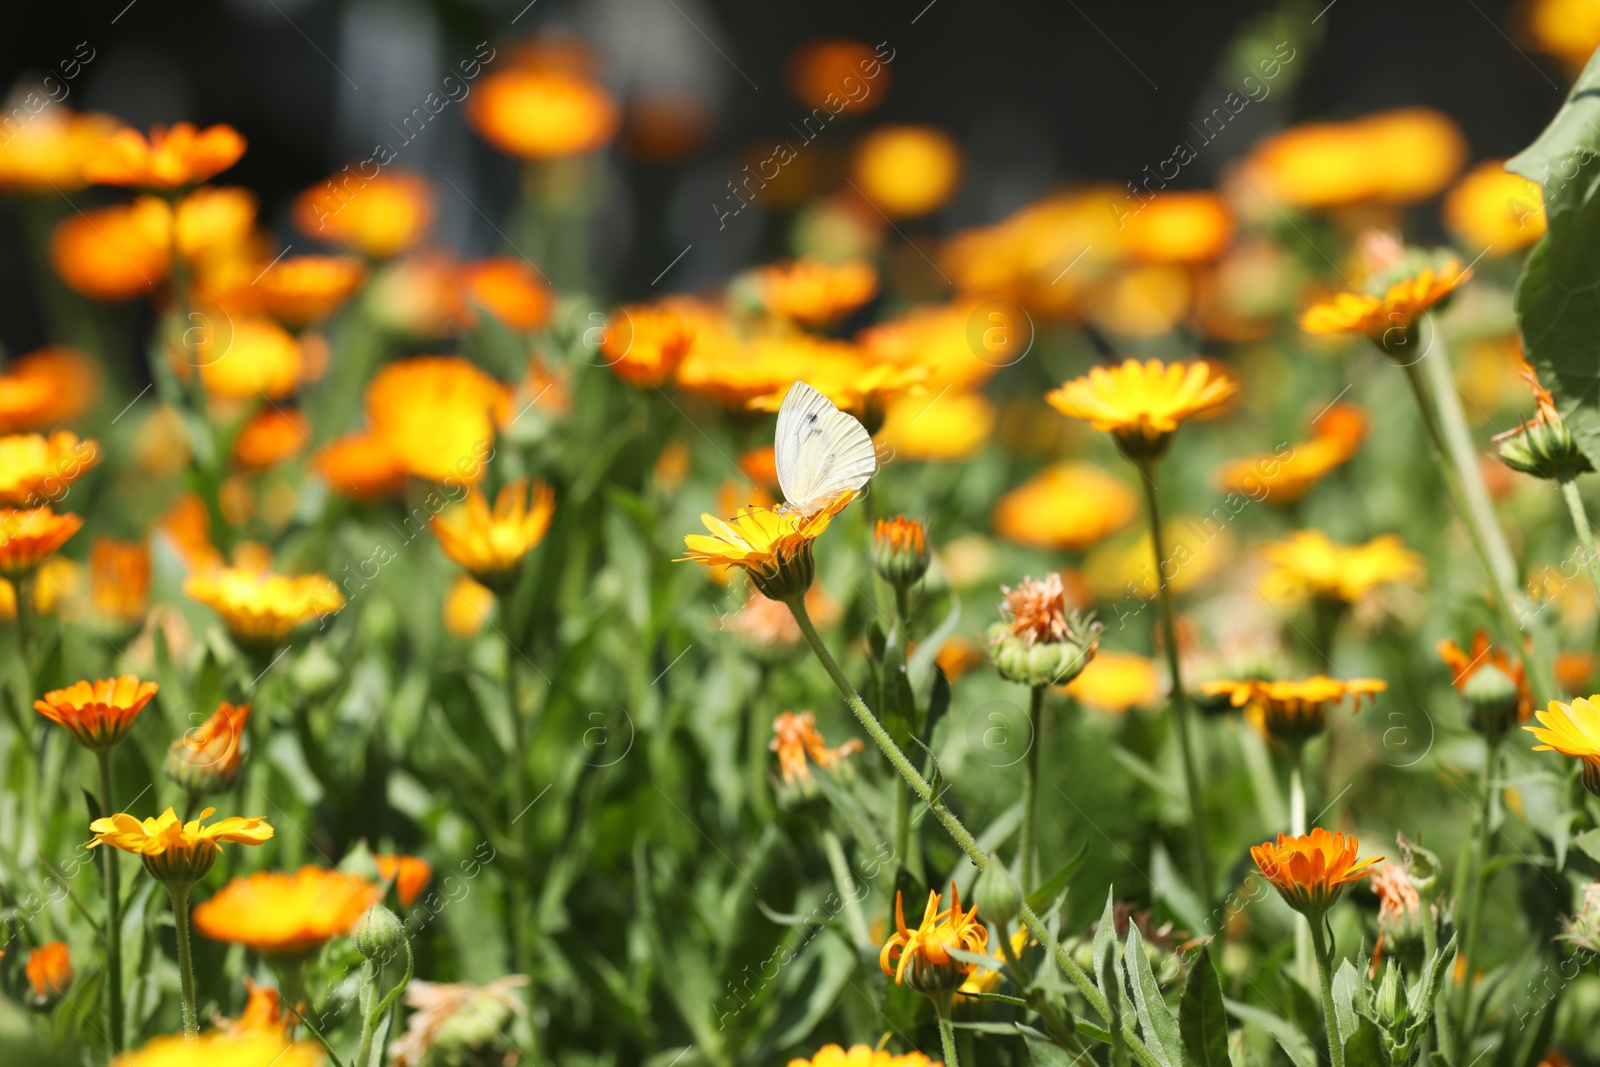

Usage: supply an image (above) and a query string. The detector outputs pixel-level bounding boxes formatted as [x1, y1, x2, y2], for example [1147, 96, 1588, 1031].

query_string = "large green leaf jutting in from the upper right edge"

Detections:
[1506, 54, 1600, 467]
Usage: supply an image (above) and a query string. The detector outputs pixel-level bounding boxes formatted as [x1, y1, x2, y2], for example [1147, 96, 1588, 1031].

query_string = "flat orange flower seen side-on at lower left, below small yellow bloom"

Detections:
[194, 867, 381, 958]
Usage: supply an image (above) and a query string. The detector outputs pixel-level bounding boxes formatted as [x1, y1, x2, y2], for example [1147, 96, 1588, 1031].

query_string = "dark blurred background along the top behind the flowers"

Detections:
[0, 0, 1568, 352]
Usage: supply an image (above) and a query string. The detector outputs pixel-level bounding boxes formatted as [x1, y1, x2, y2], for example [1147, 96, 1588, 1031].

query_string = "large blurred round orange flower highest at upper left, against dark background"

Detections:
[467, 66, 621, 160]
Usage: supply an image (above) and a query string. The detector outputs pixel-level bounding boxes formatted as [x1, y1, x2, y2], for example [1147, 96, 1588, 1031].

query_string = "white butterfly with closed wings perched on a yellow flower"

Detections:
[773, 382, 878, 517]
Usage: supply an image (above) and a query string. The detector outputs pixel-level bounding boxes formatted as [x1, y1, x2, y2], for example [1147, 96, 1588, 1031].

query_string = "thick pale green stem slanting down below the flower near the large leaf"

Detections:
[1405, 329, 1557, 704]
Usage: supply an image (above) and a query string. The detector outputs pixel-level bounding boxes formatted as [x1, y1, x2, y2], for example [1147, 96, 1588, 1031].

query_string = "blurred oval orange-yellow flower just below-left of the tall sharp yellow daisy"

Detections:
[990, 462, 1139, 549]
